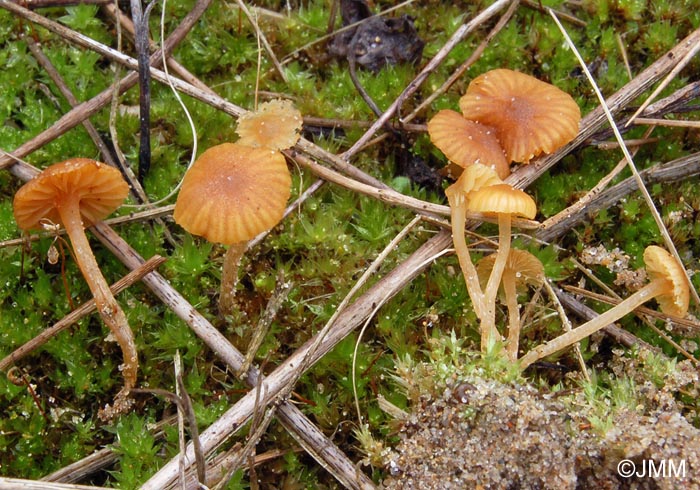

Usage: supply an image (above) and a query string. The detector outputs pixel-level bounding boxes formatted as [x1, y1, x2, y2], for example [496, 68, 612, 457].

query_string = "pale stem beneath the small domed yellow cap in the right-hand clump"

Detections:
[481, 213, 511, 352]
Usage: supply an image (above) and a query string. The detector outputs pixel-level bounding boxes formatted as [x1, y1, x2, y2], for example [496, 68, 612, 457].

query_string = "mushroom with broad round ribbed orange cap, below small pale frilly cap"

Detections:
[173, 143, 292, 314]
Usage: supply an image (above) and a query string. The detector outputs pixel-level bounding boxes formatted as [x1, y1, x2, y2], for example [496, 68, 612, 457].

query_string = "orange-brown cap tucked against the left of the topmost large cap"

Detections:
[428, 110, 510, 179]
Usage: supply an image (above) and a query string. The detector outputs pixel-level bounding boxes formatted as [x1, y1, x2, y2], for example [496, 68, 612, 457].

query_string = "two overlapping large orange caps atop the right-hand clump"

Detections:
[428, 68, 581, 179]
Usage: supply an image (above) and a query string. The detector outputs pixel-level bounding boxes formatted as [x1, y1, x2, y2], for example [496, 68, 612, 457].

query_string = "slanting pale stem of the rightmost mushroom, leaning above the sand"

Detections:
[520, 279, 669, 369]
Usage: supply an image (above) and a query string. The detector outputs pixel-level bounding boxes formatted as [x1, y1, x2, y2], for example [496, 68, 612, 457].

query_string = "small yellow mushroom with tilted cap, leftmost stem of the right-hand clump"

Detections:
[445, 163, 503, 319]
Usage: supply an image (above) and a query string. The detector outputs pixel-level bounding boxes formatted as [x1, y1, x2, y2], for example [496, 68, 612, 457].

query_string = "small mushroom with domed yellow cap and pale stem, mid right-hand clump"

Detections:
[467, 184, 537, 351]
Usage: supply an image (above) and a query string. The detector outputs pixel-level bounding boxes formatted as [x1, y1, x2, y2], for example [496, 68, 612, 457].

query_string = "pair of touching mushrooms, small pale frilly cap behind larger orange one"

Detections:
[173, 100, 302, 314]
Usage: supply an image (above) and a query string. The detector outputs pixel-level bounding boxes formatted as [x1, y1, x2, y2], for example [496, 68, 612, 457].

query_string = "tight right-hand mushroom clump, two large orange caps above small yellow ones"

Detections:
[428, 69, 581, 352]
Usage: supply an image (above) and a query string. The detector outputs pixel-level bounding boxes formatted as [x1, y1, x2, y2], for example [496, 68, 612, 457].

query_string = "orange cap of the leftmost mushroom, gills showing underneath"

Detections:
[14, 158, 129, 230]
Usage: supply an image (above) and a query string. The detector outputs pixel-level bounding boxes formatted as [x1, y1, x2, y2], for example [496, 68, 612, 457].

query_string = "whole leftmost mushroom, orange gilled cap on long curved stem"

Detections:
[13, 158, 138, 411]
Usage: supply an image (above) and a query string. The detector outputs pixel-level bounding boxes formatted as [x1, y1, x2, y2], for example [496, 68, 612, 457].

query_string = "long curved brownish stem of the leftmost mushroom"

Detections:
[57, 198, 139, 397]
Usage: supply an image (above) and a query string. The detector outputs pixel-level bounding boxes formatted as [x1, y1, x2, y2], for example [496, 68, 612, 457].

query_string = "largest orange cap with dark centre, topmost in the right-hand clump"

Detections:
[459, 69, 581, 163]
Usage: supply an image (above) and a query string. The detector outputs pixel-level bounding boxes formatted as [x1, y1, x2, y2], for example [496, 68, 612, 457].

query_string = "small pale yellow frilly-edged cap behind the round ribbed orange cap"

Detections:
[236, 99, 303, 150]
